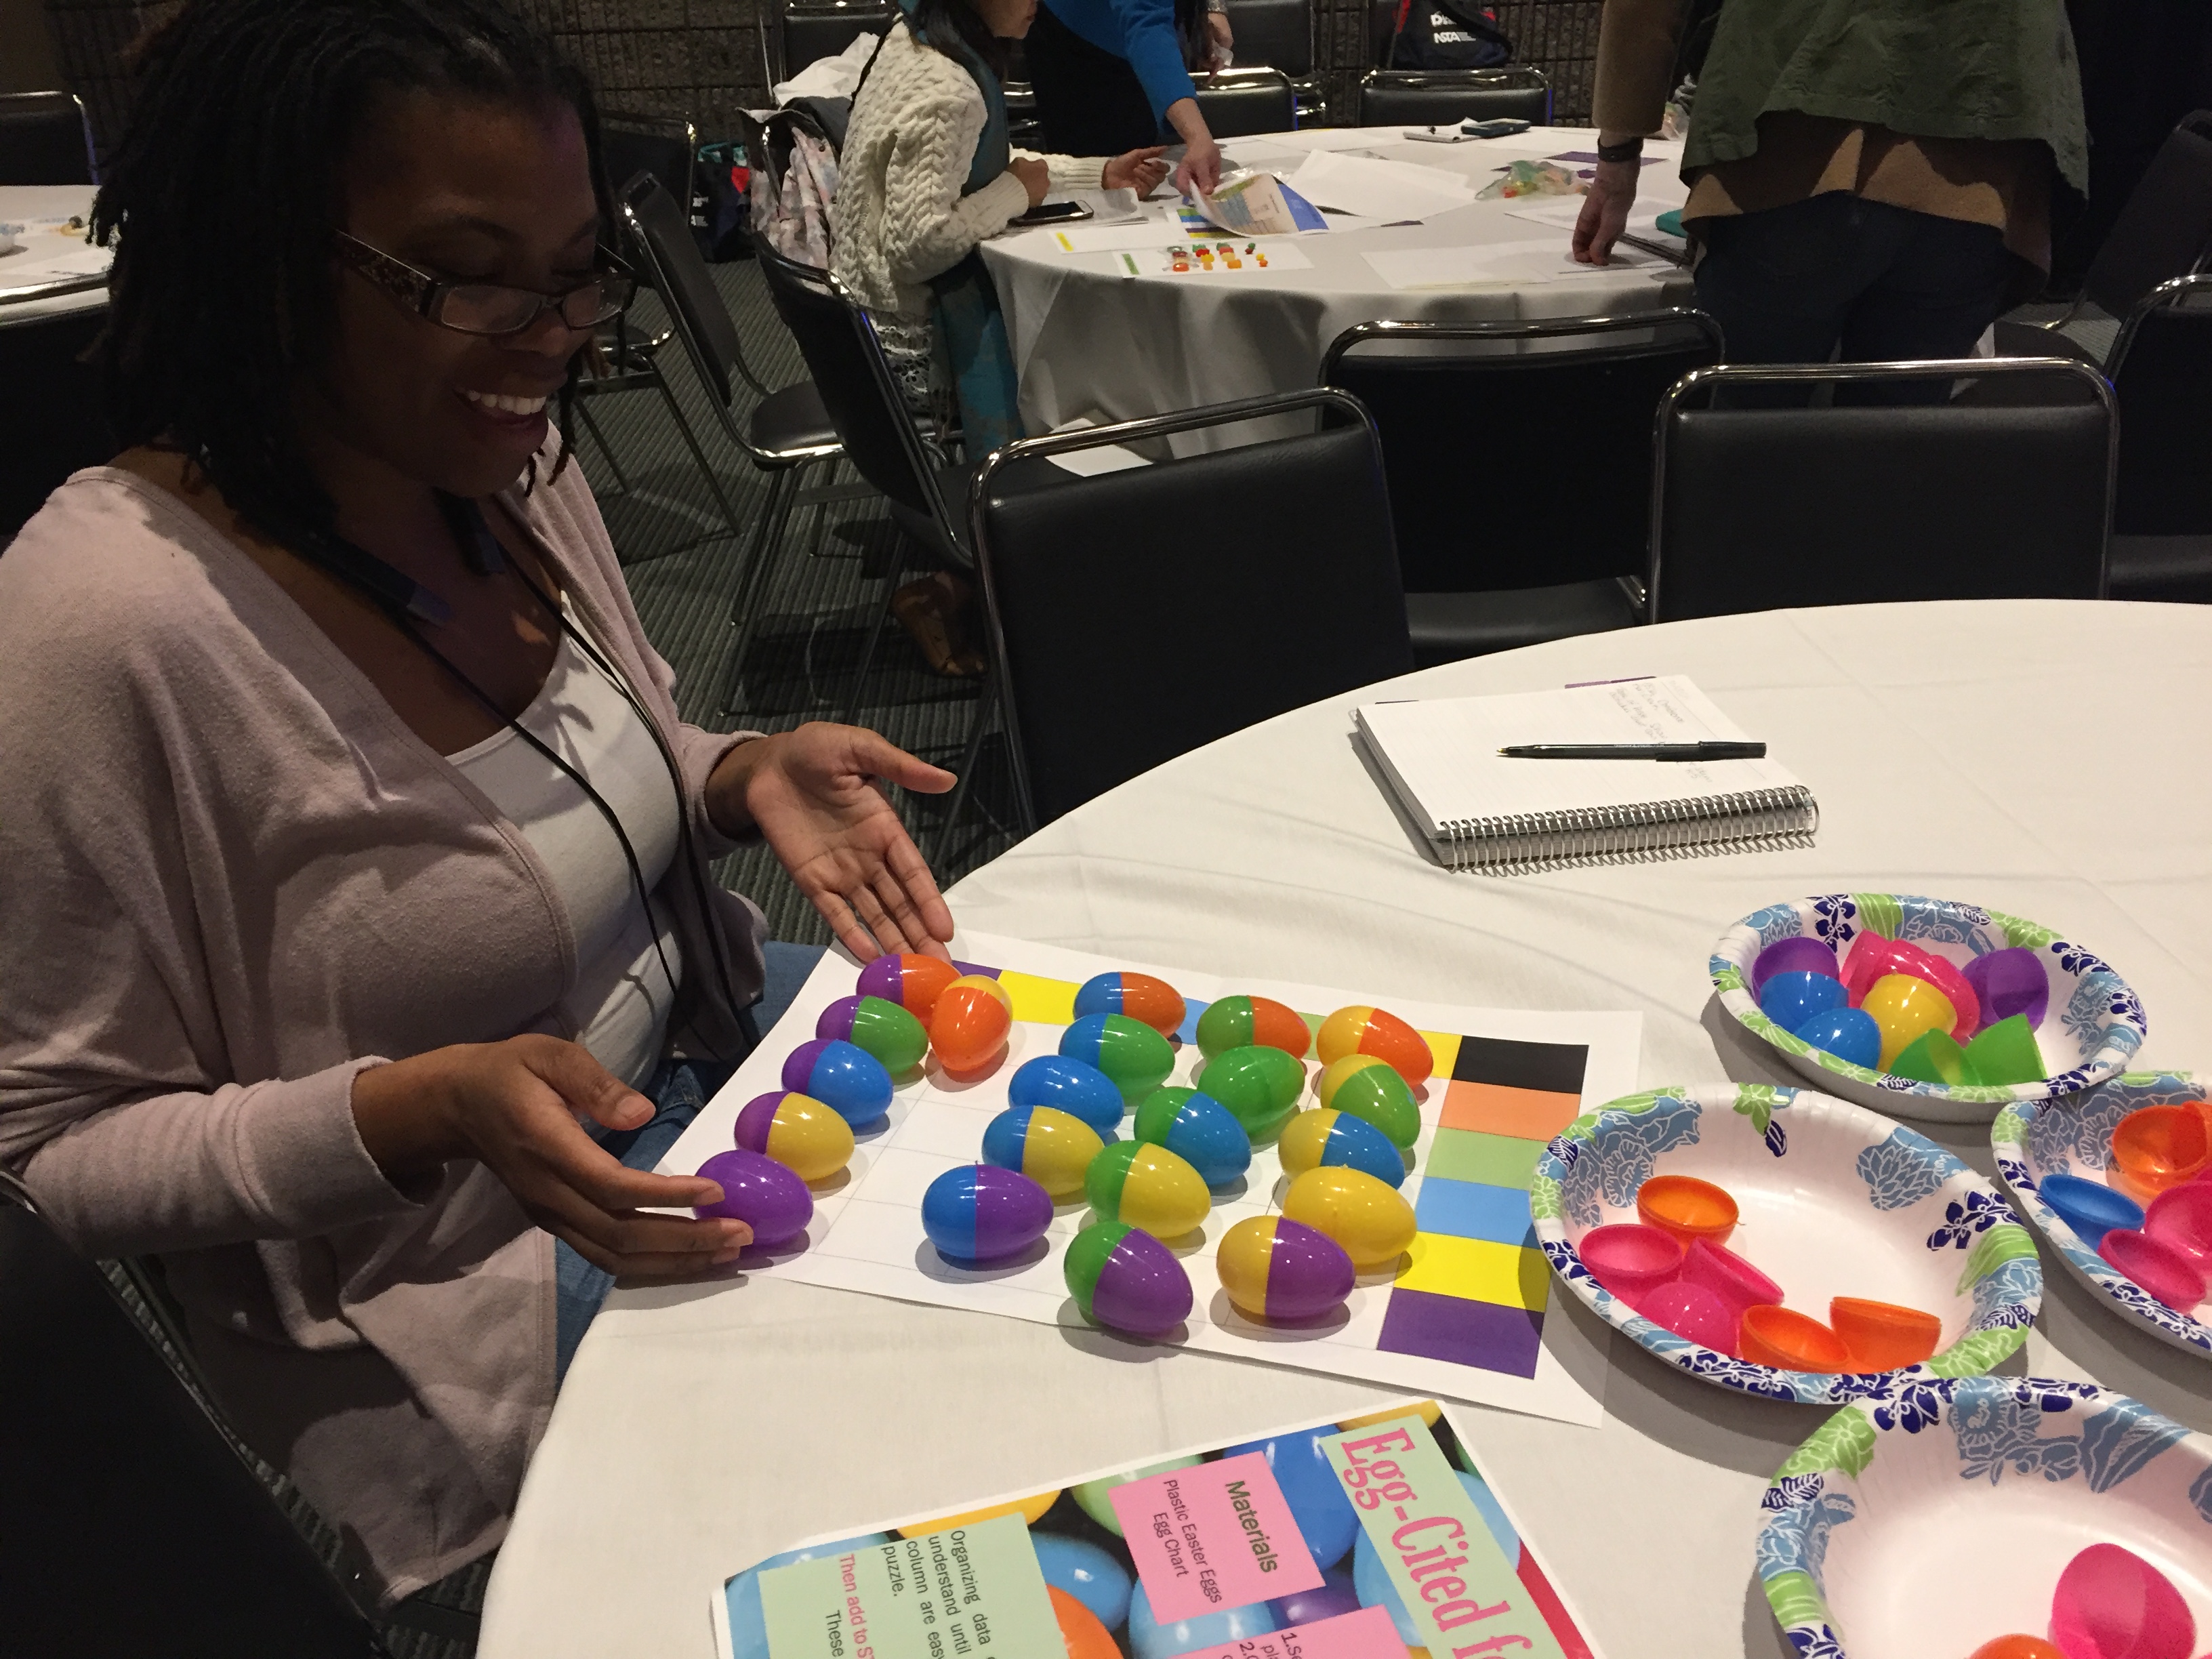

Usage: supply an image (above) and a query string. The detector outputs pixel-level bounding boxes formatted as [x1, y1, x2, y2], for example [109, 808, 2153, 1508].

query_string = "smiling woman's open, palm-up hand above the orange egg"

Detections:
[705, 721, 956, 962]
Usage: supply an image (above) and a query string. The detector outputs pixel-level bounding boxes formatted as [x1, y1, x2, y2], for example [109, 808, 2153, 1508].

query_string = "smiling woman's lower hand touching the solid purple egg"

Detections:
[354, 1036, 752, 1279]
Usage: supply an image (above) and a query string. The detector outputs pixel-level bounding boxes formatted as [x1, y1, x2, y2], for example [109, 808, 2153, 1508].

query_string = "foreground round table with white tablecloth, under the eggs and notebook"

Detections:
[478, 602, 2212, 1659]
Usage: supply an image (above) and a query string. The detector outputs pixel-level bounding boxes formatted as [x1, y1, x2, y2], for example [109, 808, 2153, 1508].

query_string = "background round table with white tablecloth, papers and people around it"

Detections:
[982, 126, 1690, 445]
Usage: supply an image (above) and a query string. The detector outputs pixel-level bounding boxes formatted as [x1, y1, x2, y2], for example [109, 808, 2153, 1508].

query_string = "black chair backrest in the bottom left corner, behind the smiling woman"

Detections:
[0, 1172, 383, 1659]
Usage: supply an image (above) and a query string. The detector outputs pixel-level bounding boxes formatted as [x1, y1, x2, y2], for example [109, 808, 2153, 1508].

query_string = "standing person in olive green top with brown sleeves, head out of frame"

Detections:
[1573, 0, 2088, 396]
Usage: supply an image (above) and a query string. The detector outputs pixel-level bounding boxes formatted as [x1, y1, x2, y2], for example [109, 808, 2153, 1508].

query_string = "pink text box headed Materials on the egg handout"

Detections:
[1108, 1451, 1321, 1624]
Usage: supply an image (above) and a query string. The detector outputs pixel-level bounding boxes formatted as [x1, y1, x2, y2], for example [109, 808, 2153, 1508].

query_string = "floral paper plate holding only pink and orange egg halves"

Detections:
[1528, 1084, 2044, 1405]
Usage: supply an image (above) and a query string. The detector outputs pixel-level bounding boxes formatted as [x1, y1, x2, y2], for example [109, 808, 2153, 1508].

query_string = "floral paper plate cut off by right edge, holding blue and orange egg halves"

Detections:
[1988, 1071, 2212, 1358]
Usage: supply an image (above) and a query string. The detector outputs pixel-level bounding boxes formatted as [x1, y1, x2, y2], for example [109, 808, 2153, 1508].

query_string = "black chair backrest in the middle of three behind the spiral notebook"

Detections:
[1321, 310, 1721, 593]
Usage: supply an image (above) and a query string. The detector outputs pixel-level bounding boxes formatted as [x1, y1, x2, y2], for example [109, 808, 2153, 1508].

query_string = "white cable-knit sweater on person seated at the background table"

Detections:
[830, 20, 1106, 323]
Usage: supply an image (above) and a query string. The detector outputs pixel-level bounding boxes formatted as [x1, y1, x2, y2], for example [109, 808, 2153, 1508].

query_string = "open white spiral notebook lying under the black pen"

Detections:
[1354, 675, 1820, 869]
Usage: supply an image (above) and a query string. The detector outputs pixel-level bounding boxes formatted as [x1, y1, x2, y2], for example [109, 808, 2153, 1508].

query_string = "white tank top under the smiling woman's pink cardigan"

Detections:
[447, 602, 684, 1088]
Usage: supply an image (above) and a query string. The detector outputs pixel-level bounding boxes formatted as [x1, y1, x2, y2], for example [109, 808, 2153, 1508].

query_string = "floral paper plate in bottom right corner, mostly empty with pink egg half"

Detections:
[1759, 1376, 2212, 1659]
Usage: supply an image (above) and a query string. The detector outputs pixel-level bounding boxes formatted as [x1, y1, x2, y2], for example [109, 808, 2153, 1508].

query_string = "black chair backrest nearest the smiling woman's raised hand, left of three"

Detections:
[969, 389, 1414, 823]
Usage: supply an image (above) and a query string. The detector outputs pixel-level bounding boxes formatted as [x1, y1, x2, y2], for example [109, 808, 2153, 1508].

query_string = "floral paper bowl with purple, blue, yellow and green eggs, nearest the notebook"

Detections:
[1710, 894, 2146, 1124]
